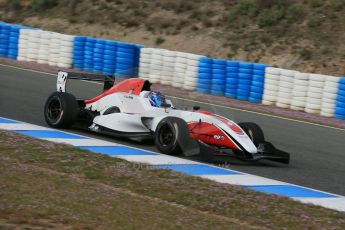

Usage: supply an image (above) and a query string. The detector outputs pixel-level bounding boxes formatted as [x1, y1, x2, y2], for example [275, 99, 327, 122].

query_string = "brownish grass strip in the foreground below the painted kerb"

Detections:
[0, 131, 345, 229]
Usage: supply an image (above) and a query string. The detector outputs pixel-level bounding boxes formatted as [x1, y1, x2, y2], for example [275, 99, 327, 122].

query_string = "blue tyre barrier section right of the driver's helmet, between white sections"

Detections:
[197, 58, 267, 103]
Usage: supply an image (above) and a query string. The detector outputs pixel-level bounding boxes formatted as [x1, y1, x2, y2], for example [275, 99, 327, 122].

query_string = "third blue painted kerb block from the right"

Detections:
[78, 146, 159, 156]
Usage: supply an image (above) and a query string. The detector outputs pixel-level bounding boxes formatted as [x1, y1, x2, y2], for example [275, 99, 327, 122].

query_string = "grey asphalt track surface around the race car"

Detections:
[0, 65, 345, 195]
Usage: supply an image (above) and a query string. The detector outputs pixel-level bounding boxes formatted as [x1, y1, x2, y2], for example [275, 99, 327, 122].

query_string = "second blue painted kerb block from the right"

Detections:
[155, 164, 241, 175]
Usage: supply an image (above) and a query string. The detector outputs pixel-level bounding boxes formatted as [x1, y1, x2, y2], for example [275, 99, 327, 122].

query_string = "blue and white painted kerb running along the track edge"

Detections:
[0, 117, 345, 212]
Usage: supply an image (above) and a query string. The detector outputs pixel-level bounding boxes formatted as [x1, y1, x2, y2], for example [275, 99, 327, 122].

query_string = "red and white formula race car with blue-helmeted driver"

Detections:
[44, 71, 290, 164]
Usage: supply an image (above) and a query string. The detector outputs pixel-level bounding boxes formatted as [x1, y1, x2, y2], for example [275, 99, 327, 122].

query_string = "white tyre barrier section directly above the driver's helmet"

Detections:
[139, 48, 203, 90]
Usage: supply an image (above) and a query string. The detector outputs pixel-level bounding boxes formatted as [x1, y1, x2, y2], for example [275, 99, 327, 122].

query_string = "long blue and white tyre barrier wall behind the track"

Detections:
[0, 22, 345, 119]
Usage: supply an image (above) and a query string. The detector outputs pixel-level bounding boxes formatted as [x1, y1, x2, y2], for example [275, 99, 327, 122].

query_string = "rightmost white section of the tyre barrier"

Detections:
[262, 67, 339, 117]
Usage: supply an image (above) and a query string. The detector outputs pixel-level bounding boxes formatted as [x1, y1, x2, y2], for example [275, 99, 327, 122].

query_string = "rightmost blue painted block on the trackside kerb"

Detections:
[245, 185, 338, 198]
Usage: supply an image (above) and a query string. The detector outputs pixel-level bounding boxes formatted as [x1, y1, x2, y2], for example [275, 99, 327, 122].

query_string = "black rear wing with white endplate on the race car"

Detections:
[56, 71, 115, 92]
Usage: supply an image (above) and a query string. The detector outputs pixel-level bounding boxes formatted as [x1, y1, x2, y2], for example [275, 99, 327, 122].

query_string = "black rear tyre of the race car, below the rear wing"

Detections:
[44, 92, 79, 128]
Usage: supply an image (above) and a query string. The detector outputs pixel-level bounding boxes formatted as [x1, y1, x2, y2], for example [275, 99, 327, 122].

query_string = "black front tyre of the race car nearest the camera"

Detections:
[154, 117, 191, 155]
